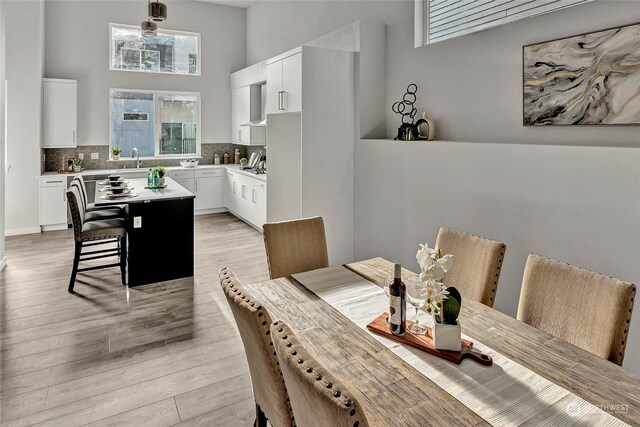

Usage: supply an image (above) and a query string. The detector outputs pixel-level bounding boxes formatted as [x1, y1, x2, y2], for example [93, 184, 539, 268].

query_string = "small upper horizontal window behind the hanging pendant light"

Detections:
[109, 24, 200, 76]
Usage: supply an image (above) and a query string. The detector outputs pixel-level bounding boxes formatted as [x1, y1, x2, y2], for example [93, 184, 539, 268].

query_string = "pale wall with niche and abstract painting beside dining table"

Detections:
[247, 1, 640, 373]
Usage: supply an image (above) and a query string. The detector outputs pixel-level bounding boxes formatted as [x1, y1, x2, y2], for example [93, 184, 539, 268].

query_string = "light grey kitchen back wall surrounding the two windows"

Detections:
[45, 0, 246, 147]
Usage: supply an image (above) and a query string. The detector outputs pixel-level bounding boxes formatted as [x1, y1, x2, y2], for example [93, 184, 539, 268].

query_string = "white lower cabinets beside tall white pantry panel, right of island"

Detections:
[223, 170, 267, 229]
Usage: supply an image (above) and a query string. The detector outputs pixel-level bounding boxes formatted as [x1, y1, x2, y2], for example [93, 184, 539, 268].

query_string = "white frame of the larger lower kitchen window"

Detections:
[109, 87, 202, 160]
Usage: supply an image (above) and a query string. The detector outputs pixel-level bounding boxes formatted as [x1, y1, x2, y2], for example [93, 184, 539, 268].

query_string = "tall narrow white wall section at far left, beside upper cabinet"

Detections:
[4, 1, 44, 235]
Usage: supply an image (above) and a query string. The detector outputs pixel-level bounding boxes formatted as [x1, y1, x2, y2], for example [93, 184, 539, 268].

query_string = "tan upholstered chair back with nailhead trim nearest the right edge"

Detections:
[517, 254, 636, 365]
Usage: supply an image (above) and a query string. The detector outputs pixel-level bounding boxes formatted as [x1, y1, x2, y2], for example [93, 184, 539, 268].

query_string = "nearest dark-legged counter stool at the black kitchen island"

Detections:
[67, 185, 127, 293]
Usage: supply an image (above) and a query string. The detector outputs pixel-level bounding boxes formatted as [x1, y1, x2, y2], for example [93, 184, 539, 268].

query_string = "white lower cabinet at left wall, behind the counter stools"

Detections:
[40, 176, 67, 231]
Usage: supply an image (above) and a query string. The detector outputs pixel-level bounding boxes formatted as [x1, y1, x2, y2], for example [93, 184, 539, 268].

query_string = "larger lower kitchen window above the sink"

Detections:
[109, 89, 200, 157]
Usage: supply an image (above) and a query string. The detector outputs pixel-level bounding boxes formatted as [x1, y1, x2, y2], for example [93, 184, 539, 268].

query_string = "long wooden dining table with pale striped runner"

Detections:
[245, 258, 640, 426]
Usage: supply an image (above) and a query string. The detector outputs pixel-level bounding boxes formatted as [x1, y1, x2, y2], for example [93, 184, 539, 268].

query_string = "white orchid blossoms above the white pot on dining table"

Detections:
[416, 242, 453, 316]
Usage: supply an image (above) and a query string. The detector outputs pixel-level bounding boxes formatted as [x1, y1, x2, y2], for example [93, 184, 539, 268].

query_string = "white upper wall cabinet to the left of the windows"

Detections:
[42, 79, 78, 148]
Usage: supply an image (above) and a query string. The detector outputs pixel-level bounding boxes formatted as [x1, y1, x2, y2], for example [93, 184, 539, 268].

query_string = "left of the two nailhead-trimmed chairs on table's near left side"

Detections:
[218, 268, 295, 427]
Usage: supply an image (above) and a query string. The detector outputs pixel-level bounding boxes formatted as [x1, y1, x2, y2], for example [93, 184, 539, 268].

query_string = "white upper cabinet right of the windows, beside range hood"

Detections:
[231, 85, 266, 145]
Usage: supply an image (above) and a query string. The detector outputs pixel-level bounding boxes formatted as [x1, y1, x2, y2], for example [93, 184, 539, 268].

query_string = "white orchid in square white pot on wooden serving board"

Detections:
[416, 243, 462, 351]
